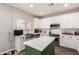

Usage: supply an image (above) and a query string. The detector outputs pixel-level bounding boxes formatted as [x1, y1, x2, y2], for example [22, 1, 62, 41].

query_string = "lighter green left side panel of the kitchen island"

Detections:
[25, 45, 41, 55]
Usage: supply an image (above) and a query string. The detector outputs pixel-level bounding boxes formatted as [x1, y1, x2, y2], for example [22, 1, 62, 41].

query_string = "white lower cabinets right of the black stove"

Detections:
[60, 35, 76, 49]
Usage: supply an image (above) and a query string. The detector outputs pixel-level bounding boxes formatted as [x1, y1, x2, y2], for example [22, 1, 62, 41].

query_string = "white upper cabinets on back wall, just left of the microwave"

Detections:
[34, 18, 50, 28]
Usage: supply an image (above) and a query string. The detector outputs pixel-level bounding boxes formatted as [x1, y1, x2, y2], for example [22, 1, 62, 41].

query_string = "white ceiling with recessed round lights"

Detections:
[7, 3, 79, 17]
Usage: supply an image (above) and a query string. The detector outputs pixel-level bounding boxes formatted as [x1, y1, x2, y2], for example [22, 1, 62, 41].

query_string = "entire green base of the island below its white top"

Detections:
[25, 42, 55, 55]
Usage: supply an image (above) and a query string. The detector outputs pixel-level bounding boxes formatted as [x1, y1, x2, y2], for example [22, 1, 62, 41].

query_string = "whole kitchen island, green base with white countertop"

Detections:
[23, 36, 55, 55]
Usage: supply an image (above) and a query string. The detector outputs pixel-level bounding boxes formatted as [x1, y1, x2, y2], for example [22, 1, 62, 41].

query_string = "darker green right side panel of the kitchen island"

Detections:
[41, 42, 55, 55]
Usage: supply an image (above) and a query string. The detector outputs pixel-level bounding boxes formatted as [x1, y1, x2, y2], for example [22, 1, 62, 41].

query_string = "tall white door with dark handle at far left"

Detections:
[0, 4, 11, 53]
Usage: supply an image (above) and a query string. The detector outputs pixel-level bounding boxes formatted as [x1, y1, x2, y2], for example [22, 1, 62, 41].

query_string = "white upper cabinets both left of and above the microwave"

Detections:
[34, 16, 61, 28]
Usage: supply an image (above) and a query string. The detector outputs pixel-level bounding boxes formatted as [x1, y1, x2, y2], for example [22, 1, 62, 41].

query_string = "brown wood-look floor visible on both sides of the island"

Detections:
[18, 46, 78, 55]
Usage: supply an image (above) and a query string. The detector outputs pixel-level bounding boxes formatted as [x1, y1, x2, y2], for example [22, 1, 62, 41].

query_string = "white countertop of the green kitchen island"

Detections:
[23, 36, 55, 51]
